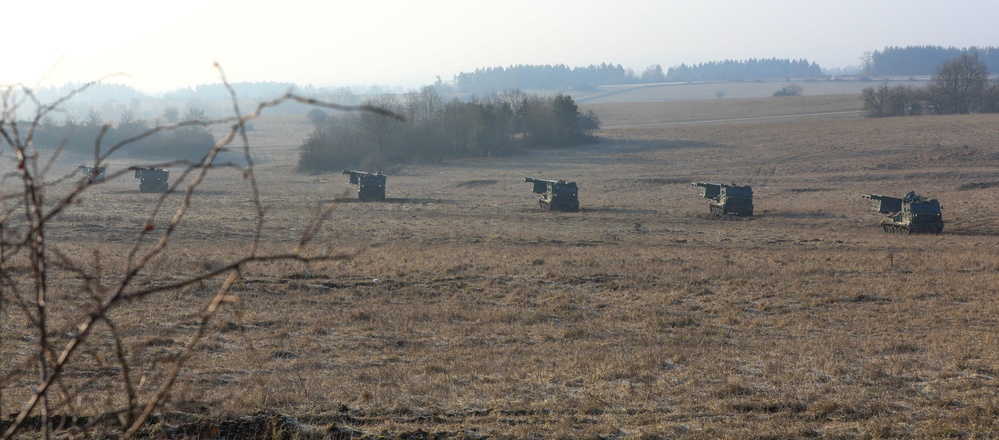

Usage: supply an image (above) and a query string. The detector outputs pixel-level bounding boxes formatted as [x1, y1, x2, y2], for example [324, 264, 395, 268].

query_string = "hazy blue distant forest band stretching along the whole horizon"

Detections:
[21, 46, 999, 131]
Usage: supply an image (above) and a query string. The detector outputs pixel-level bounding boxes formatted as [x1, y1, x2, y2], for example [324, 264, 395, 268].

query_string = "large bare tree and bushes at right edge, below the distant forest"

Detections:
[860, 52, 999, 117]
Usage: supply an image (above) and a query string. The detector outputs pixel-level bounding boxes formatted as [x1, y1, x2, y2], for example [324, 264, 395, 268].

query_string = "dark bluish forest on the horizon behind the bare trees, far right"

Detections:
[861, 46, 999, 76]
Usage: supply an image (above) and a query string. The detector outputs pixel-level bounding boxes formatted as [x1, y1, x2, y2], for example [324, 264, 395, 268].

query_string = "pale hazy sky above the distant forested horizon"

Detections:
[7, 0, 999, 93]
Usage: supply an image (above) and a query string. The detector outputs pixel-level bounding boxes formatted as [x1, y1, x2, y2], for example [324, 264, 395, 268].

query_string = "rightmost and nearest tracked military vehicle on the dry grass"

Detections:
[863, 191, 943, 234]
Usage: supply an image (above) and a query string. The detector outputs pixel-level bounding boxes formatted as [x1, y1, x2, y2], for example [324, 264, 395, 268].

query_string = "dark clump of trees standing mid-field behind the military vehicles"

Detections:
[298, 86, 600, 172]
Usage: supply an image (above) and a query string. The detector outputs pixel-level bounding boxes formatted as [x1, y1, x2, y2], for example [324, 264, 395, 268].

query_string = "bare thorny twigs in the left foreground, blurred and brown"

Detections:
[0, 65, 402, 438]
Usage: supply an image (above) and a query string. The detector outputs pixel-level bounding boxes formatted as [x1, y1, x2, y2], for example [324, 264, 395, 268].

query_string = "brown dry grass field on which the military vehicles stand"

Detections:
[0, 91, 999, 439]
